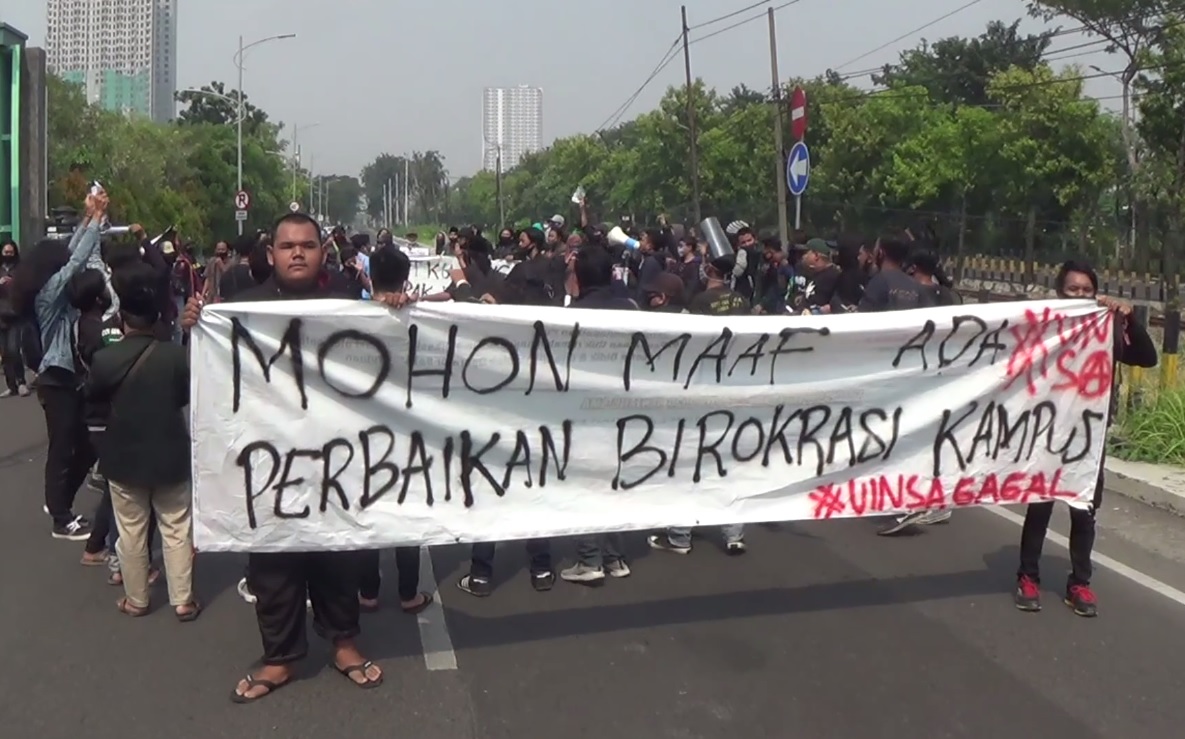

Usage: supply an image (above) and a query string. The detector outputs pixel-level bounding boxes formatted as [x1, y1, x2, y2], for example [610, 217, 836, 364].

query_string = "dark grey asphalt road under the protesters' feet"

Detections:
[0, 398, 1185, 739]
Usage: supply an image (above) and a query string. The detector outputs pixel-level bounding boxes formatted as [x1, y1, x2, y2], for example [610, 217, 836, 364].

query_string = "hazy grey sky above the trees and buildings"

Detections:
[0, 0, 1119, 178]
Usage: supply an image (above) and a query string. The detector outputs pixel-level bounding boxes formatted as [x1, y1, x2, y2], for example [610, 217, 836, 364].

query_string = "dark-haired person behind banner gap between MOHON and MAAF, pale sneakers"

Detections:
[559, 246, 638, 585]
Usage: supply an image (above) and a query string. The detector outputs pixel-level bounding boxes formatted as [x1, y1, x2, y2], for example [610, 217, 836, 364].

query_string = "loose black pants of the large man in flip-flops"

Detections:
[246, 552, 360, 664]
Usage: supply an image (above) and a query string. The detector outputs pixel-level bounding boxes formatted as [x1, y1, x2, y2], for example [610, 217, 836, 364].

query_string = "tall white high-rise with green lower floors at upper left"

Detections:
[45, 0, 178, 122]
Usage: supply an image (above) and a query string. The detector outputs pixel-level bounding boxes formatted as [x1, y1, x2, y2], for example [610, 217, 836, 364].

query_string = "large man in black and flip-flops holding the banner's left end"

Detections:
[182, 213, 388, 703]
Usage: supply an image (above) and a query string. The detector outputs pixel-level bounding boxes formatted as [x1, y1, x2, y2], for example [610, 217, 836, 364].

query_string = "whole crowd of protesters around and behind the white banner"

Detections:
[0, 185, 1157, 702]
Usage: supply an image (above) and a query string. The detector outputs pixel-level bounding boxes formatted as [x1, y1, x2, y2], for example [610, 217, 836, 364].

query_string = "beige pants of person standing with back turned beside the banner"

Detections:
[110, 480, 193, 608]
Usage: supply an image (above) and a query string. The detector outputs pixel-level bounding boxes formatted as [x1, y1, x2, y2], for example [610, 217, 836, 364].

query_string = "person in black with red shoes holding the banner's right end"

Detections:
[1013, 261, 1157, 618]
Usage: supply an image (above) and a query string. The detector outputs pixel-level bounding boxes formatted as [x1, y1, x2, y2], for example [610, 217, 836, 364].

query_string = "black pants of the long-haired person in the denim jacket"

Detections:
[37, 385, 95, 526]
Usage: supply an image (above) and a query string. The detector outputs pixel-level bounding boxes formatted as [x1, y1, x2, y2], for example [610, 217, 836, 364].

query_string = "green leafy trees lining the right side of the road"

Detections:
[453, 18, 1185, 268]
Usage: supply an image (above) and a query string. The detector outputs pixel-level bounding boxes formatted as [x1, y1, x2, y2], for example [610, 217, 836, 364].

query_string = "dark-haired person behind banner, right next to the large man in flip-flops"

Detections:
[358, 244, 433, 613]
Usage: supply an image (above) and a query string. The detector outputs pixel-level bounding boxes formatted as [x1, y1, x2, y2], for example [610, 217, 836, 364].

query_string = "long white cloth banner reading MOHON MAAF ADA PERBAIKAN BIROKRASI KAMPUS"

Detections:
[192, 301, 1112, 552]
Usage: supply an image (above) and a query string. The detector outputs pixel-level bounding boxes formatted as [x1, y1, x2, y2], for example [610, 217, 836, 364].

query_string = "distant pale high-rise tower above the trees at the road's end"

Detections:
[481, 85, 543, 171]
